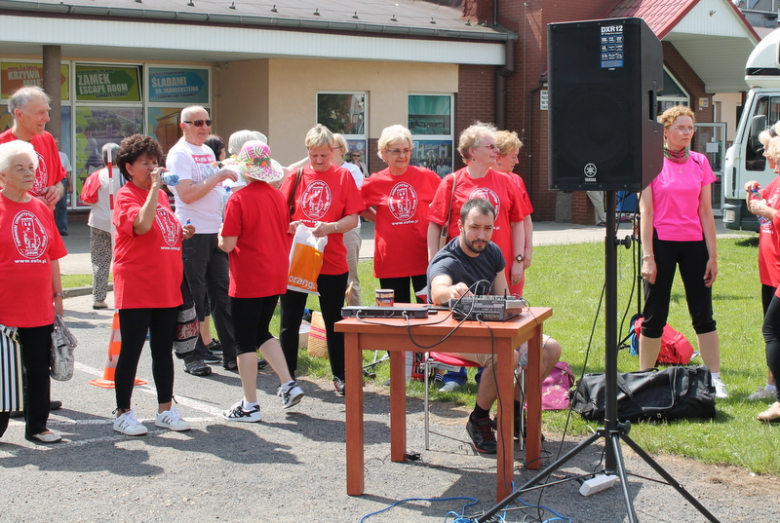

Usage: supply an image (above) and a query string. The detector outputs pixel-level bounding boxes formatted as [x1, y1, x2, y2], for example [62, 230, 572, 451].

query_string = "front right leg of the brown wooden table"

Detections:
[495, 338, 515, 501]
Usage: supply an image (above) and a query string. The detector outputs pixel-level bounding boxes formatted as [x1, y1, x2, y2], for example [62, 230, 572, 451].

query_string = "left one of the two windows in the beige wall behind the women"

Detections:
[317, 92, 368, 158]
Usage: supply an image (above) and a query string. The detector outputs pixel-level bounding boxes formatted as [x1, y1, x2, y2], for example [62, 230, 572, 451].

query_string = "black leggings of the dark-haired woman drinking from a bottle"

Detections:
[114, 307, 179, 410]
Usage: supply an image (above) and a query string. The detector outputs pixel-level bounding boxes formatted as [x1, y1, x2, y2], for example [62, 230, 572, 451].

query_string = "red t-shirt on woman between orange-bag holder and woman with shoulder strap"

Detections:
[360, 166, 441, 278]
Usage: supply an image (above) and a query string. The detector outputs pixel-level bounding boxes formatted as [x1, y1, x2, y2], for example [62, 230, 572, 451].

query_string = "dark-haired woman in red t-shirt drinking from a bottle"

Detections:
[113, 134, 195, 436]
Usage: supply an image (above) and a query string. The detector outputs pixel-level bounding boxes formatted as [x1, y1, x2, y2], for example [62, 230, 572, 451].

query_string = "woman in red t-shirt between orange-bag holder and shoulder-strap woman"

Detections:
[360, 125, 441, 303]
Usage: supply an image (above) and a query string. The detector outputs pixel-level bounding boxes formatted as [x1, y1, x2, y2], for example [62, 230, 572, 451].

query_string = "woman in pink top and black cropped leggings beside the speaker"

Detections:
[639, 105, 728, 398]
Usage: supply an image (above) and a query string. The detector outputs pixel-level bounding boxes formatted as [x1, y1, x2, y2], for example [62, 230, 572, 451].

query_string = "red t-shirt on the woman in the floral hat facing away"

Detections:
[222, 181, 290, 298]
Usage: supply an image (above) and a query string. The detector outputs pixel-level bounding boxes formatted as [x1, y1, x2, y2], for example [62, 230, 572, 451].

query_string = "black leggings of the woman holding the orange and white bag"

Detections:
[279, 272, 349, 380]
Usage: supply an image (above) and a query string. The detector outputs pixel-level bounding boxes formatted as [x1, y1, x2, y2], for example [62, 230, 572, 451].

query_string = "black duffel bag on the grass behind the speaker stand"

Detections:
[571, 366, 715, 421]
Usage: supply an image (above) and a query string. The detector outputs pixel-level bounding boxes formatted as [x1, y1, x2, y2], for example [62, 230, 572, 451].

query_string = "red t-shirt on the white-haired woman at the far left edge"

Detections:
[0, 195, 67, 327]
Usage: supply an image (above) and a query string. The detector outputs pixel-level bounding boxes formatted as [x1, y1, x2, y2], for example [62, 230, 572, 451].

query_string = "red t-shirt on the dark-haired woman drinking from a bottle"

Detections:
[113, 182, 184, 309]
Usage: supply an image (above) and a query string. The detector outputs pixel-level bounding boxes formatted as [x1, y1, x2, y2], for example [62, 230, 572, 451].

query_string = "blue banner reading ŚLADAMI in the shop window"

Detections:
[149, 67, 209, 104]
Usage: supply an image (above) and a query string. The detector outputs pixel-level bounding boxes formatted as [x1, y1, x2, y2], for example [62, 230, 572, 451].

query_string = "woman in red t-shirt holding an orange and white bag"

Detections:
[279, 124, 365, 394]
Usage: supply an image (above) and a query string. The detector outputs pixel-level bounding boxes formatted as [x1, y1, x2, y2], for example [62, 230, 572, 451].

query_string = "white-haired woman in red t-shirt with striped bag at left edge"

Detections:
[0, 140, 67, 443]
